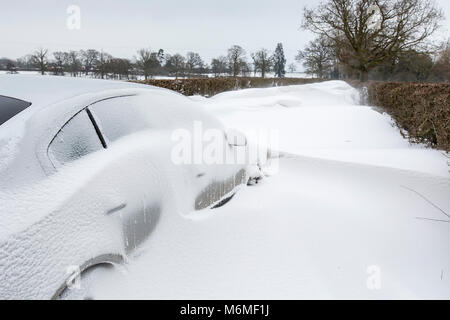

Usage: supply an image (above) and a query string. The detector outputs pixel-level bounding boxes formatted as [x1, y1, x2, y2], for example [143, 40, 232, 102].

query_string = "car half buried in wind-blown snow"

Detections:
[0, 75, 248, 299]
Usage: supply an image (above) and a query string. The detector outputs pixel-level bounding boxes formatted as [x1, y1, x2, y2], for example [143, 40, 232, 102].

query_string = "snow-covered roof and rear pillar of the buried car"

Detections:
[0, 75, 197, 192]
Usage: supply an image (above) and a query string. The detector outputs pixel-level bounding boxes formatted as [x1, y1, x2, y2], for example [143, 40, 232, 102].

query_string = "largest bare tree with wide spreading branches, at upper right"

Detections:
[302, 0, 443, 81]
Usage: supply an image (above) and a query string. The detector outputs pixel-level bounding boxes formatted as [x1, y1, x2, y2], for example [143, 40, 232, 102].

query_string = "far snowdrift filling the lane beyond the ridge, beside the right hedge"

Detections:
[204, 81, 450, 177]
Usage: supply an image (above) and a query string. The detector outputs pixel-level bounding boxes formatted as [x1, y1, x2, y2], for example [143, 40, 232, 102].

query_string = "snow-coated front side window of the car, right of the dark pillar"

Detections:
[89, 97, 150, 142]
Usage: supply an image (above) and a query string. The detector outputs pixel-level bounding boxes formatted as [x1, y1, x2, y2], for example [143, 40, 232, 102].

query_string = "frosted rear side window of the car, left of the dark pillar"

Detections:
[48, 110, 103, 168]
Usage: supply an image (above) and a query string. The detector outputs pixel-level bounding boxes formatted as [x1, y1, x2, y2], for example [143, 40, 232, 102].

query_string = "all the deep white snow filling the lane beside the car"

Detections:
[70, 81, 450, 299]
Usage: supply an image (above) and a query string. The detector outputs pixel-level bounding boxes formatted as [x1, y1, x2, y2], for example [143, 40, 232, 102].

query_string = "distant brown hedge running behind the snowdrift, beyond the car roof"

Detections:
[129, 77, 320, 97]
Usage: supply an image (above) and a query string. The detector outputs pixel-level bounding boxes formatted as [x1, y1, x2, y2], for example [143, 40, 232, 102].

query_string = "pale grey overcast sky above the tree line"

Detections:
[0, 0, 450, 63]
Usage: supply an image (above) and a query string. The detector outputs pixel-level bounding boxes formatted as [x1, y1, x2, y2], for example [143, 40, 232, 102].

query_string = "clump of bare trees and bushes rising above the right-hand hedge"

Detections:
[296, 0, 450, 82]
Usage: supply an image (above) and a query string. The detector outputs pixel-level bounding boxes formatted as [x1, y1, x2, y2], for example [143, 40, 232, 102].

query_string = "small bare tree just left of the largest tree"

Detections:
[295, 36, 335, 79]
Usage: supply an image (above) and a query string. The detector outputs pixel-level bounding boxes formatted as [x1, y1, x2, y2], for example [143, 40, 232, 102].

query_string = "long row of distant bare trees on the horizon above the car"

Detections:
[0, 43, 288, 80]
